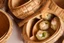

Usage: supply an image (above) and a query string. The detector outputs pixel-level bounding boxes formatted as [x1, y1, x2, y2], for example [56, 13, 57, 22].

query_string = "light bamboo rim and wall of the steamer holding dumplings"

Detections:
[23, 10, 64, 43]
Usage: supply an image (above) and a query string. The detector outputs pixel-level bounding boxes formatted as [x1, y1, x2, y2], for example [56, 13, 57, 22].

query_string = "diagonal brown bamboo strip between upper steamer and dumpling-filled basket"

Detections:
[18, 0, 50, 27]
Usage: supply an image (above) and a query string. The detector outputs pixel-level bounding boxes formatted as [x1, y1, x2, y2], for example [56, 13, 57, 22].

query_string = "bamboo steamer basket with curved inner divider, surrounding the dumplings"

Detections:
[23, 10, 64, 43]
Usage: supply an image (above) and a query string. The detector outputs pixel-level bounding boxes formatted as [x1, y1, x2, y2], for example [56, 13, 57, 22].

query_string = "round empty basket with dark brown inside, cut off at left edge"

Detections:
[0, 10, 13, 43]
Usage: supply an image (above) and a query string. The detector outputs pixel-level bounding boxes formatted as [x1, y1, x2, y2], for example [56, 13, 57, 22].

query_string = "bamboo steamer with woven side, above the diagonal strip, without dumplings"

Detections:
[8, 0, 47, 19]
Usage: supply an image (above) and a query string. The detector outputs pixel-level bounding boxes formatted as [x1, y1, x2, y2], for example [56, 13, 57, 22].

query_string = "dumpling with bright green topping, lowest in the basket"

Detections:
[36, 30, 49, 40]
